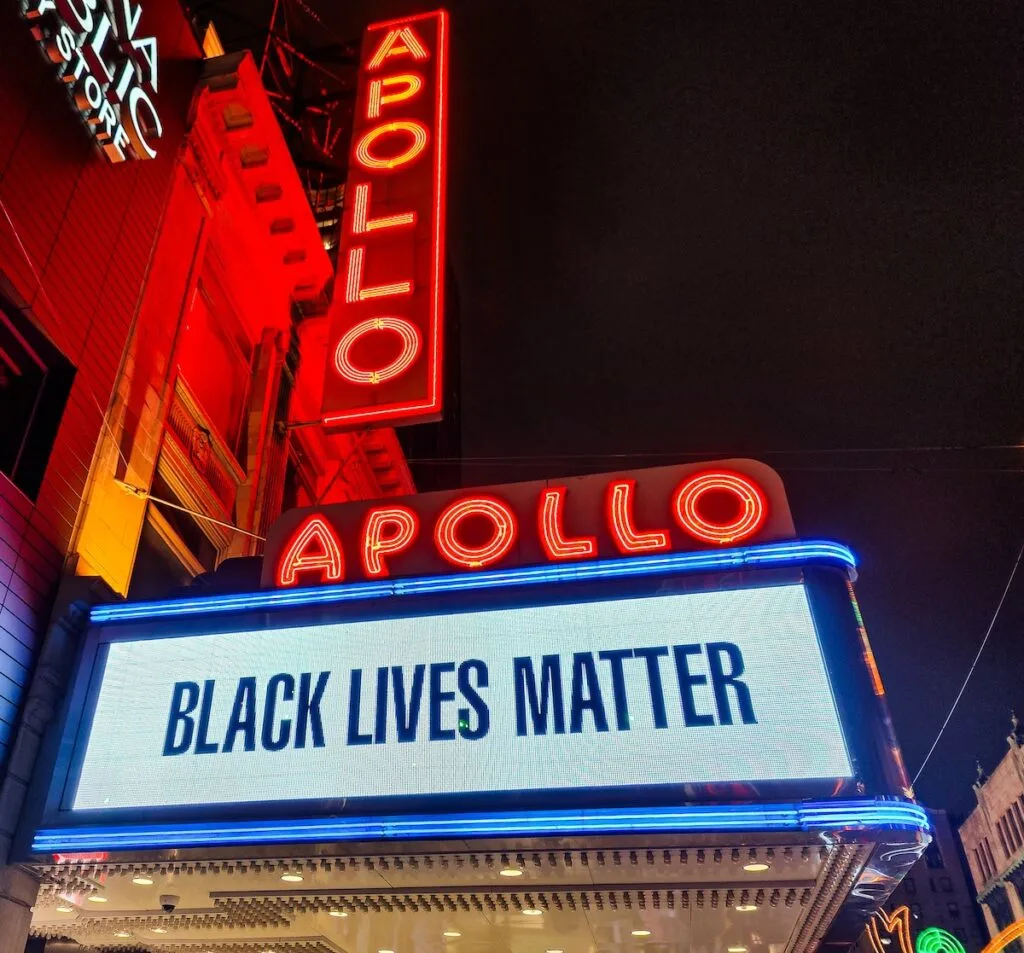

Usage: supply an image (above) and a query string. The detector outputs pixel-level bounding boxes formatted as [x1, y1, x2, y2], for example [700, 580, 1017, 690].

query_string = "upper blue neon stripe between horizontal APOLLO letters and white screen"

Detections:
[90, 539, 857, 622]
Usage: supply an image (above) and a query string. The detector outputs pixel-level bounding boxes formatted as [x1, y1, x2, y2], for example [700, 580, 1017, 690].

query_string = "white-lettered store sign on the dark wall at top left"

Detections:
[25, 0, 163, 162]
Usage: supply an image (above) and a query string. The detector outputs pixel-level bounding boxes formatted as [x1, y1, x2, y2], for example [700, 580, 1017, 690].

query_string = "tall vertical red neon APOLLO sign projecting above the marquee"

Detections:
[323, 10, 447, 427]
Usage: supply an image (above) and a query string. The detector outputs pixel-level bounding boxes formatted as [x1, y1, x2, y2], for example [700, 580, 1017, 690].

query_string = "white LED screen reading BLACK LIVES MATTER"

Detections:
[73, 586, 852, 811]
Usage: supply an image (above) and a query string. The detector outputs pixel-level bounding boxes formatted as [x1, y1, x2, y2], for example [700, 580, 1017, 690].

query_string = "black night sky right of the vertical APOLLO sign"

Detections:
[232, 0, 1024, 812]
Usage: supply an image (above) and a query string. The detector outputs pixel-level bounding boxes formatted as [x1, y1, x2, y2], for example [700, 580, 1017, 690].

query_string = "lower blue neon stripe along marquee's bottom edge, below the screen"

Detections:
[32, 800, 931, 854]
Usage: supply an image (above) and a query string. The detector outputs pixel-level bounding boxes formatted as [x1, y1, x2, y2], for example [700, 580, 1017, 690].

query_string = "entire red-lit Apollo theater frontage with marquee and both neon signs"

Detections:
[0, 0, 930, 953]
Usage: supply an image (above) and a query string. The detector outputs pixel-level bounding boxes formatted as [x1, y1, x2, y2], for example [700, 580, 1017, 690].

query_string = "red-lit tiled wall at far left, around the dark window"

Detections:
[0, 0, 200, 768]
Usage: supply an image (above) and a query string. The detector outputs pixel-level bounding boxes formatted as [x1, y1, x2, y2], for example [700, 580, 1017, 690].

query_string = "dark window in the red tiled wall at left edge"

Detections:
[0, 298, 75, 500]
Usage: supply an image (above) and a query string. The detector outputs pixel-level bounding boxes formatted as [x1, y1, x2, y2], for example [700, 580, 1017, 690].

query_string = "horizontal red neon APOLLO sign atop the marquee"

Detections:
[263, 460, 794, 587]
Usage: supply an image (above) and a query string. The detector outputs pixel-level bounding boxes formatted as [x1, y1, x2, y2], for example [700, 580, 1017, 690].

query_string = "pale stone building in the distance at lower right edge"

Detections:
[959, 714, 1024, 937]
